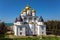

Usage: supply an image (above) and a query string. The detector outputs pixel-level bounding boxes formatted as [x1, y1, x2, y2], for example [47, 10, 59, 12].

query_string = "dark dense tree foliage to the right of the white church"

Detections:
[45, 20, 60, 35]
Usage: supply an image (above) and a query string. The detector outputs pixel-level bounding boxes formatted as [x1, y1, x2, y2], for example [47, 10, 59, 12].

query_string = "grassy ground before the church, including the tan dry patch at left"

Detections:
[0, 34, 60, 40]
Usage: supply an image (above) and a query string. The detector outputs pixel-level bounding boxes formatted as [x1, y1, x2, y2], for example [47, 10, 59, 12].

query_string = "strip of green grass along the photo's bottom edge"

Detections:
[0, 36, 60, 40]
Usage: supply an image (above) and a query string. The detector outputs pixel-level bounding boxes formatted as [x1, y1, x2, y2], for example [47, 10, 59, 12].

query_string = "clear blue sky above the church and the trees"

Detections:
[0, 0, 60, 23]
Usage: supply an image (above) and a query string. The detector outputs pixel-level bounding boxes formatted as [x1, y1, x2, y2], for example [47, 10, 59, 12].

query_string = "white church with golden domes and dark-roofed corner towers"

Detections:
[13, 6, 46, 36]
